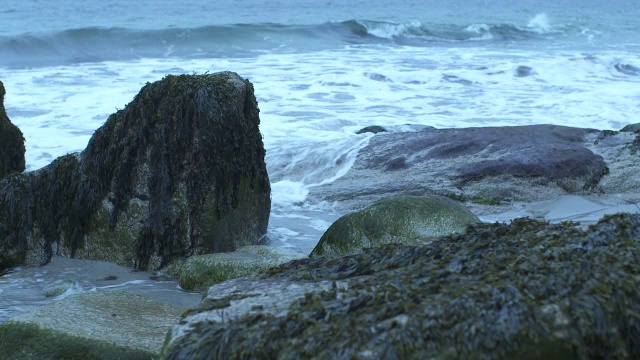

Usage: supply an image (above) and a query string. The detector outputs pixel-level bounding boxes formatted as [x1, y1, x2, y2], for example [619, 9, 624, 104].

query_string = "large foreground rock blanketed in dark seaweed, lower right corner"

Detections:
[162, 214, 640, 359]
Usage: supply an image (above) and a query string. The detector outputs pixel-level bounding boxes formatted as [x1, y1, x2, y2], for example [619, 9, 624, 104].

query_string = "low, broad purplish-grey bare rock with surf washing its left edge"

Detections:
[309, 125, 608, 208]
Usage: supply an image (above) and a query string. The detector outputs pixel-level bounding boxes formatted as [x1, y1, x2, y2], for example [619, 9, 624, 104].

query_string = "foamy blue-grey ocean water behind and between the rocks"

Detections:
[0, 0, 640, 321]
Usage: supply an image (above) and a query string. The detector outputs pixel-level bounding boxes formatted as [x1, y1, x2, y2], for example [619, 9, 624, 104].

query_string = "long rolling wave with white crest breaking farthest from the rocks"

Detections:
[0, 14, 558, 68]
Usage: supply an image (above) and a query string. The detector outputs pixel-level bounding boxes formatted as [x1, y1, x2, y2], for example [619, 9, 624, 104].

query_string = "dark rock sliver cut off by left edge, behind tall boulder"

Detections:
[0, 81, 25, 179]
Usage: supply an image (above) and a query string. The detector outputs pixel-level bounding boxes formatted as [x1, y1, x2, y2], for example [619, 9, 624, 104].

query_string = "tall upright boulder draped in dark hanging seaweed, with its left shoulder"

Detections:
[0, 72, 271, 271]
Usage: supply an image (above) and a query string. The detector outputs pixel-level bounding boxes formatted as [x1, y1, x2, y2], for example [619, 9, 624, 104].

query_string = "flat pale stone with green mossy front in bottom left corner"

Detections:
[0, 291, 180, 360]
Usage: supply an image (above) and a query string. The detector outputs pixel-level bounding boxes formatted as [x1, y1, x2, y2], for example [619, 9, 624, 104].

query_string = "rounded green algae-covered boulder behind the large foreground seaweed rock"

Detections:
[311, 196, 479, 257]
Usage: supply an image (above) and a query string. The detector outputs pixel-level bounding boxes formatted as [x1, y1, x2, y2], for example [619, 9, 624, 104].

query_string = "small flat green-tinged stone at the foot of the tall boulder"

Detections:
[178, 245, 306, 291]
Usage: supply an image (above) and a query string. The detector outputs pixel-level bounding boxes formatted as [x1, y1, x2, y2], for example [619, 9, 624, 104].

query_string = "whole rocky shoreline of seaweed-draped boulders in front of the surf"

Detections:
[0, 72, 640, 359]
